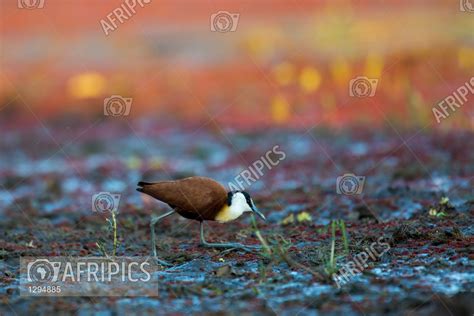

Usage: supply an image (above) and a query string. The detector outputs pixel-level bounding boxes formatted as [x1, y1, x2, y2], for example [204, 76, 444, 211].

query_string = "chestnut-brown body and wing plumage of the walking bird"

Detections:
[138, 177, 227, 220]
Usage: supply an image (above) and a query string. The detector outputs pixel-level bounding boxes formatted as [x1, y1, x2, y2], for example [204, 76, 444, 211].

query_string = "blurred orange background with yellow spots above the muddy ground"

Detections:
[0, 0, 474, 129]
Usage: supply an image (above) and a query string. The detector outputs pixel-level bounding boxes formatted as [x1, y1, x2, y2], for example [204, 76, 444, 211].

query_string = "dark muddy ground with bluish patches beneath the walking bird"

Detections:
[0, 118, 474, 315]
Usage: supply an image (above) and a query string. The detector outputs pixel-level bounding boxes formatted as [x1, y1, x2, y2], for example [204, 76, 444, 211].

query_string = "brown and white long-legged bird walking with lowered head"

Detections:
[137, 176, 266, 266]
